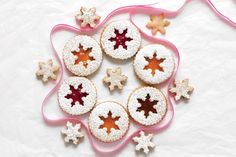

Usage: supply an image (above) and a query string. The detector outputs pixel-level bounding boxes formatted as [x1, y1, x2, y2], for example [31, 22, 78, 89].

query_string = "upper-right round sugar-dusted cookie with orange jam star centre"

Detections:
[133, 44, 175, 84]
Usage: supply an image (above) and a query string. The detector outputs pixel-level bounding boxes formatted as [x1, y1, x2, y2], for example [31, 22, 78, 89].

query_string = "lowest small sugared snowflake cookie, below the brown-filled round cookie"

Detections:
[133, 131, 155, 154]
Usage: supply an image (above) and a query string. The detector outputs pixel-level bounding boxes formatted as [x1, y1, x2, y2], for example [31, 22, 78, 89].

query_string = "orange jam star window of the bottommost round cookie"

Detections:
[99, 111, 120, 134]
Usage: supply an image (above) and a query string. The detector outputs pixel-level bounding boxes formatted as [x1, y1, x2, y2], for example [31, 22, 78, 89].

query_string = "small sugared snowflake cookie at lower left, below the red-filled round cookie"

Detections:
[61, 121, 84, 144]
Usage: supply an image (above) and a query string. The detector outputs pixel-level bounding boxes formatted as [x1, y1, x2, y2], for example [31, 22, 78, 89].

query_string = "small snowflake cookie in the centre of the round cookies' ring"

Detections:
[103, 67, 128, 91]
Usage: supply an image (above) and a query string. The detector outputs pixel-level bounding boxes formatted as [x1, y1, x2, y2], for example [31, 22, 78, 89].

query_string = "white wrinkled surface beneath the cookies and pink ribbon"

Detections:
[0, 0, 236, 157]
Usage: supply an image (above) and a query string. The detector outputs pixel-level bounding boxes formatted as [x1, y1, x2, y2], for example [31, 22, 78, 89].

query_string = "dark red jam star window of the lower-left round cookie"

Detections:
[65, 84, 88, 107]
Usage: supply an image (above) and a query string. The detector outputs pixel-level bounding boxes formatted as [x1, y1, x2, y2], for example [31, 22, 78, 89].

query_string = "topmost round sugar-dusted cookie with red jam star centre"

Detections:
[101, 21, 141, 59]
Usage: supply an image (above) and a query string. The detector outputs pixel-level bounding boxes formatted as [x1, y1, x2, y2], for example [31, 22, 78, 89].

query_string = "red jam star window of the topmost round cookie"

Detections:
[109, 29, 133, 50]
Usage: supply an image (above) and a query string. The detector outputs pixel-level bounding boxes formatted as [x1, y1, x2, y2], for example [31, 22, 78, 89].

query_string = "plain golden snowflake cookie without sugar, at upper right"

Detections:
[146, 14, 170, 35]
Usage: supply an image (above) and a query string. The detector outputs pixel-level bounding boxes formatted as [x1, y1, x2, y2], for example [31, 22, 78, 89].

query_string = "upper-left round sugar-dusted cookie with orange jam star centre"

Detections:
[63, 35, 102, 76]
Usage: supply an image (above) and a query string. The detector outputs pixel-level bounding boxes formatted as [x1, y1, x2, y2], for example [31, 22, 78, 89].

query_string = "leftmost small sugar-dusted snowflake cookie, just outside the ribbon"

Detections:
[36, 59, 60, 82]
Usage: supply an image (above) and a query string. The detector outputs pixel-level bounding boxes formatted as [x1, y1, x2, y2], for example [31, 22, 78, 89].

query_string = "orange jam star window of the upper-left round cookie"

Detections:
[72, 44, 95, 68]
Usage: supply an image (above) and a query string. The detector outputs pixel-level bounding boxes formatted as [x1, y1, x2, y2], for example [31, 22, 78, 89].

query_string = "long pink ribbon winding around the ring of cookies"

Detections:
[41, 0, 236, 154]
